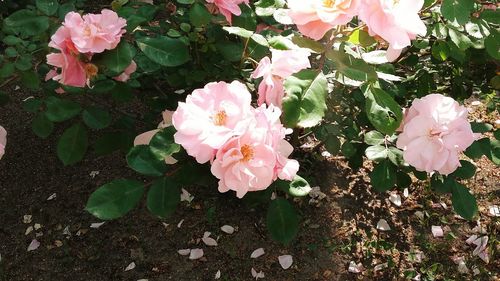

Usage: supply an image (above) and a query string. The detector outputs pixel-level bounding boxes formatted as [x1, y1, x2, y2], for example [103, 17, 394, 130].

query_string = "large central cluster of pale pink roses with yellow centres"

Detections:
[172, 81, 299, 198]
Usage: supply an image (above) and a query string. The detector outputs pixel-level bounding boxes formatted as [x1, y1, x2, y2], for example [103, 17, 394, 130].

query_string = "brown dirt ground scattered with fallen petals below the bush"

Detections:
[0, 82, 500, 281]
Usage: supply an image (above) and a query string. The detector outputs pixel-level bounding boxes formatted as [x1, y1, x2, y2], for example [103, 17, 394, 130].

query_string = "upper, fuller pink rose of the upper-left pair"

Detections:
[64, 9, 127, 53]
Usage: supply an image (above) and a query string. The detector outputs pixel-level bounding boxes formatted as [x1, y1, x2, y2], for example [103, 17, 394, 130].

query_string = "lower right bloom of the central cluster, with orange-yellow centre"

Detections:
[211, 105, 299, 198]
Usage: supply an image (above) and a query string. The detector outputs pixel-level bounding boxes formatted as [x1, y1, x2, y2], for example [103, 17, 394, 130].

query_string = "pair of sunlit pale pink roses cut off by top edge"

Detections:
[287, 0, 427, 61]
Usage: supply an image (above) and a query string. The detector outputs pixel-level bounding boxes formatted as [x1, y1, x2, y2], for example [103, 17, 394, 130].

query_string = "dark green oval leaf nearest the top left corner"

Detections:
[3, 10, 49, 36]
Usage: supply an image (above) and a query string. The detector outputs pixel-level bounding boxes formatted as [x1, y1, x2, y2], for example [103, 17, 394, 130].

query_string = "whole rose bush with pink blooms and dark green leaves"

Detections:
[0, 0, 500, 243]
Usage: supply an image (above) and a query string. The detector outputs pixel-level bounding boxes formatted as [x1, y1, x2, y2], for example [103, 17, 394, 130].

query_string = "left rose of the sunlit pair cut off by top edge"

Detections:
[287, 0, 360, 40]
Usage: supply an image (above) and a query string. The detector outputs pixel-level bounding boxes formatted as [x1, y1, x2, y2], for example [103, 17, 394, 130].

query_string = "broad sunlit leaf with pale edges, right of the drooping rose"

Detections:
[283, 70, 328, 128]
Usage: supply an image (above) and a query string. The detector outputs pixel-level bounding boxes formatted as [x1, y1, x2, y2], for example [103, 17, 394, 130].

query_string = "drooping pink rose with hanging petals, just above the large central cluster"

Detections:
[252, 49, 311, 108]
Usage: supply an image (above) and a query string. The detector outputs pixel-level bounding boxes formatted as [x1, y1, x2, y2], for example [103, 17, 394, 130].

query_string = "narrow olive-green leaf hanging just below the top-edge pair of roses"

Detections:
[326, 50, 378, 81]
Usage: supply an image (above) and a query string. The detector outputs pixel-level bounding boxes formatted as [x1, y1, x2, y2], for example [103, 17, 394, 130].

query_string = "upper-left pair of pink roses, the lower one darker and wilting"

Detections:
[45, 9, 137, 87]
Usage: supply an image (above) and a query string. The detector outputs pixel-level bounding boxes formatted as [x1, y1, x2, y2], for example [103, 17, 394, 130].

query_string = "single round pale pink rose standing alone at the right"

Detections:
[396, 94, 475, 175]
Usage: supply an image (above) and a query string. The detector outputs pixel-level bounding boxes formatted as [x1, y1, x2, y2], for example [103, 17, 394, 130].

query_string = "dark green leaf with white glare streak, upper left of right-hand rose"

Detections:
[365, 86, 403, 135]
